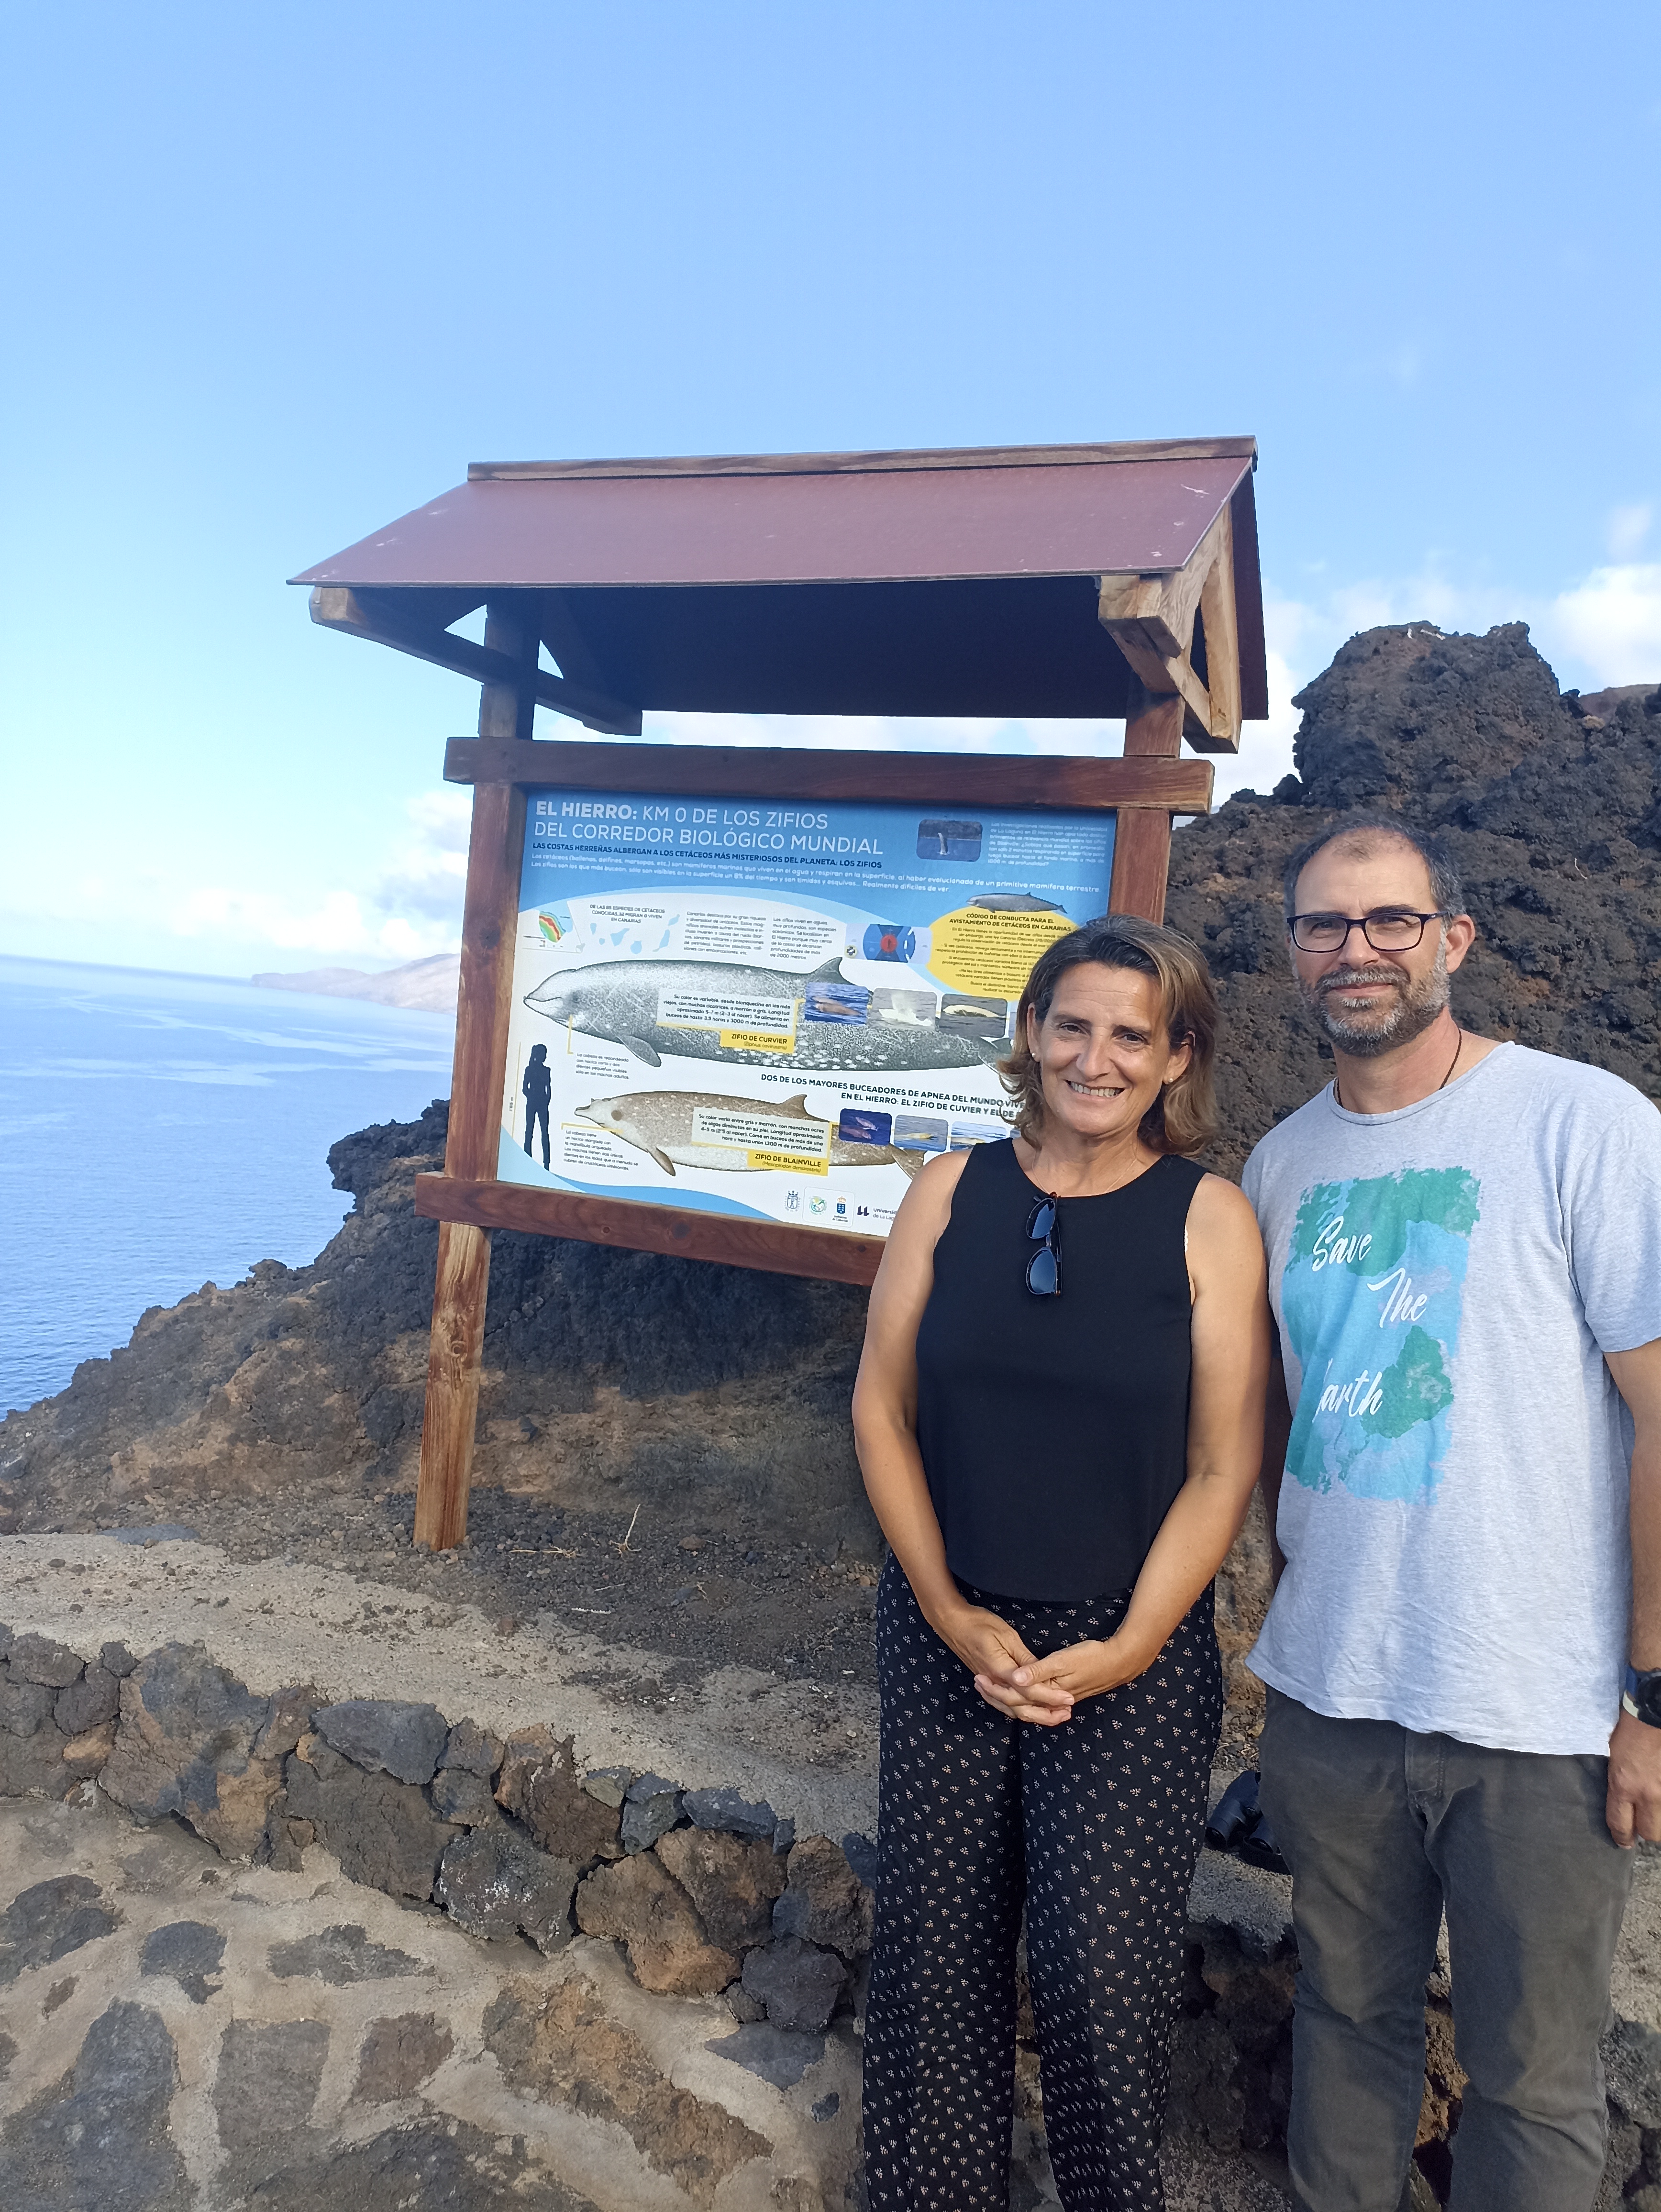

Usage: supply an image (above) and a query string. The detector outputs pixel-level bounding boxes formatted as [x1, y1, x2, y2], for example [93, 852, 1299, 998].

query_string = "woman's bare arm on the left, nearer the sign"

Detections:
[854, 1152, 1033, 1672]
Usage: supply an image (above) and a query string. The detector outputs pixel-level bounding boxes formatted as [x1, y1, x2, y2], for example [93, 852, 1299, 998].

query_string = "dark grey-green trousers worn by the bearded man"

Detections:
[1261, 1690, 1632, 2212]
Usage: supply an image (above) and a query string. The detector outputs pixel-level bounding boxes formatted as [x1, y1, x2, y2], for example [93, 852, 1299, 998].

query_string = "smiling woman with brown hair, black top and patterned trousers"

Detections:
[854, 916, 1270, 2212]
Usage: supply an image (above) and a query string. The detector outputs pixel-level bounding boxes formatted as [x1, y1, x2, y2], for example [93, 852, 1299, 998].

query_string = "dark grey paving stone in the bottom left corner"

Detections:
[0, 2002, 195, 2212]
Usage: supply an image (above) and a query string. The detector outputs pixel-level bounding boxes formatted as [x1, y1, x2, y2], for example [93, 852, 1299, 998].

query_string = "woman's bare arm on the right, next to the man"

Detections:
[977, 1174, 1270, 1725]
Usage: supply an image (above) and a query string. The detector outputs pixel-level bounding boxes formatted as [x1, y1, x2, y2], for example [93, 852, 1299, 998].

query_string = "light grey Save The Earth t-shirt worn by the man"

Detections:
[1243, 1044, 1661, 1754]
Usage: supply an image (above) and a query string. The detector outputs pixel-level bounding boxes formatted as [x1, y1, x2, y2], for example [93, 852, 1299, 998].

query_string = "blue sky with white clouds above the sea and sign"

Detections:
[0, 0, 1661, 973]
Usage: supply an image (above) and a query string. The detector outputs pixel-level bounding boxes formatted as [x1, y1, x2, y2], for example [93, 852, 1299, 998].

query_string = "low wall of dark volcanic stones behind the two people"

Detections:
[0, 1628, 1661, 2212]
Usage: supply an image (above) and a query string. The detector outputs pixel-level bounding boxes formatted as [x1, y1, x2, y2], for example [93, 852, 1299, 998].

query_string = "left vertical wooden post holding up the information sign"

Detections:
[416, 604, 540, 1550]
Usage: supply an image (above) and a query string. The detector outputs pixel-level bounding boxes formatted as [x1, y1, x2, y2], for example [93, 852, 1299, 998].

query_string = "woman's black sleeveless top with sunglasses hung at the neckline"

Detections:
[918, 1141, 1206, 1604]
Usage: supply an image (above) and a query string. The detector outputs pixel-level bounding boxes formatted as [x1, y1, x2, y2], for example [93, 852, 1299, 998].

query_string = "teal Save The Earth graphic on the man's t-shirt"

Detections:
[1281, 1168, 1482, 1500]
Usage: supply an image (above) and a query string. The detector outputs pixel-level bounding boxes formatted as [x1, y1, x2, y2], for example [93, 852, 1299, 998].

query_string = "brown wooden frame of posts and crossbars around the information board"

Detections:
[402, 664, 1212, 1548]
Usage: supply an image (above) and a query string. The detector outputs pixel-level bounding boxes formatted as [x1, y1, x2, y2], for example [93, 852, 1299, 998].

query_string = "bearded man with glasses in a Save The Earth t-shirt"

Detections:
[1243, 816, 1661, 2212]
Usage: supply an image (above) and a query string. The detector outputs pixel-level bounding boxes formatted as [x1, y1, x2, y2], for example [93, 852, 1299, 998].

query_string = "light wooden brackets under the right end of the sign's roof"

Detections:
[1097, 507, 1241, 752]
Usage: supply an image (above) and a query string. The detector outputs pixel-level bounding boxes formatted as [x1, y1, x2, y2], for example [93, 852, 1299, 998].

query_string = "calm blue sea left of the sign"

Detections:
[0, 958, 455, 1411]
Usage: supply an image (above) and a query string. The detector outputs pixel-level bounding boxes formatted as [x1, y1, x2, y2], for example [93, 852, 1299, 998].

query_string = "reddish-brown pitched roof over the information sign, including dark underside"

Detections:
[294, 438, 1267, 719]
